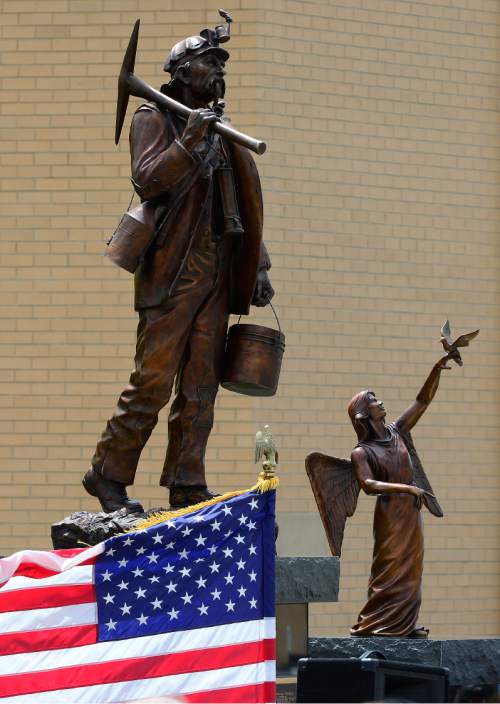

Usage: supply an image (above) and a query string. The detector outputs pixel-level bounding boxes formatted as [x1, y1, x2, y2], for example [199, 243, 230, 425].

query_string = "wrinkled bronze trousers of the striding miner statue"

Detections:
[92, 246, 229, 487]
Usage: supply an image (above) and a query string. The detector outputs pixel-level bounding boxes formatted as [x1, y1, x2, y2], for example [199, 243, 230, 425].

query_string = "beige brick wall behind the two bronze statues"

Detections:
[0, 0, 500, 637]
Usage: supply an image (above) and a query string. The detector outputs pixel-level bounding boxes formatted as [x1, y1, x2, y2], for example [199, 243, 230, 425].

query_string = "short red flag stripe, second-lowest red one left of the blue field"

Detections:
[0, 584, 95, 616]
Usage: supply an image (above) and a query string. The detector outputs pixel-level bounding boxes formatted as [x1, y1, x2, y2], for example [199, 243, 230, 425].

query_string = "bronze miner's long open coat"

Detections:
[130, 103, 270, 314]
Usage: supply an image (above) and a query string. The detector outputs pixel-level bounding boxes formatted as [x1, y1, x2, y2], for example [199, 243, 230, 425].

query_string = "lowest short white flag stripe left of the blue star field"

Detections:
[0, 602, 97, 634]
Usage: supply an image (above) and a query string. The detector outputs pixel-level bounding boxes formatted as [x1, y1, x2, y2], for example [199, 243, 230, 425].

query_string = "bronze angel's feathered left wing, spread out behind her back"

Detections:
[306, 452, 359, 555]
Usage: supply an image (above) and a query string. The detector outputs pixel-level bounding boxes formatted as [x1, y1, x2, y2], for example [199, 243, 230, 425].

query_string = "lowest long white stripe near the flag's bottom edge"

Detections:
[0, 660, 276, 704]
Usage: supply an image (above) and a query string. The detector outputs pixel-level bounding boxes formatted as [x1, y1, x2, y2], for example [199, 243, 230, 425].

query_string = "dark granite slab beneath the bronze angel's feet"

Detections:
[308, 637, 500, 686]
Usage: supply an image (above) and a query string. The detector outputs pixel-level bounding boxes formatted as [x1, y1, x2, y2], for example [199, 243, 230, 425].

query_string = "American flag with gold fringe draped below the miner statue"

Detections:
[0, 491, 276, 704]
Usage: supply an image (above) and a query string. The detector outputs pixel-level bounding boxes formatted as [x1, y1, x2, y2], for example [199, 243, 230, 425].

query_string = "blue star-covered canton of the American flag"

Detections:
[95, 491, 275, 641]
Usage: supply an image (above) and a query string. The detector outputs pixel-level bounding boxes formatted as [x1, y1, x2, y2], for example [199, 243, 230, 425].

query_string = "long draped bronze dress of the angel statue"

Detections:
[351, 424, 424, 636]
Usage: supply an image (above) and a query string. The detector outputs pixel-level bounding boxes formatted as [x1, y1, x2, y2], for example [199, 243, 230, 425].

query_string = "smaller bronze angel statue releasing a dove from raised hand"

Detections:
[306, 321, 479, 638]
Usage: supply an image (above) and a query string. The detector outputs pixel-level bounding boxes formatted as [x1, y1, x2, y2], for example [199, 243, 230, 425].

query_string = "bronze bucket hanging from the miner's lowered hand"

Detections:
[221, 308, 285, 396]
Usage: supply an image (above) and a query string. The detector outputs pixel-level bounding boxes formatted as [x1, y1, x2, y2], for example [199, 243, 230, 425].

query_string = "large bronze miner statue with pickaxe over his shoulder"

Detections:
[83, 11, 274, 512]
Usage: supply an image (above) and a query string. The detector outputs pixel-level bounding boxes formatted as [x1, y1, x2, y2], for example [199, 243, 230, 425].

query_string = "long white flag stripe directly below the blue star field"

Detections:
[0, 618, 276, 672]
